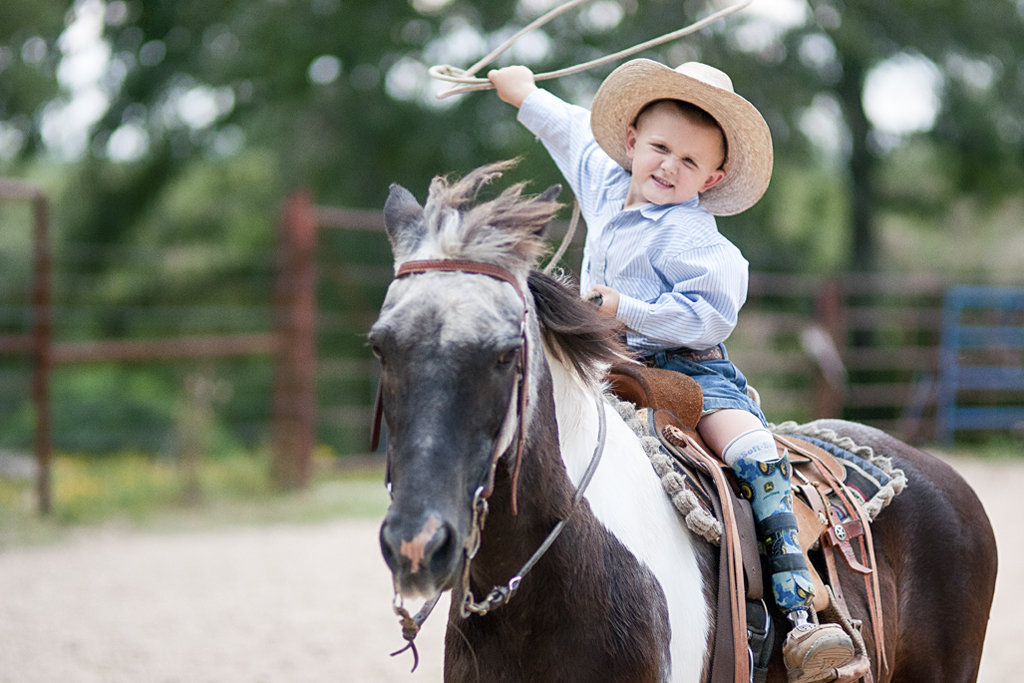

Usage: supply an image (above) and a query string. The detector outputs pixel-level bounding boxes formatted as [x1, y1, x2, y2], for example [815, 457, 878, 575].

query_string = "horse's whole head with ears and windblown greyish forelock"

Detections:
[370, 163, 559, 596]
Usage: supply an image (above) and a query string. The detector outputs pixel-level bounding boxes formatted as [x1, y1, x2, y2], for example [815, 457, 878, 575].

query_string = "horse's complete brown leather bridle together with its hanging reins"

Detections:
[385, 260, 607, 671]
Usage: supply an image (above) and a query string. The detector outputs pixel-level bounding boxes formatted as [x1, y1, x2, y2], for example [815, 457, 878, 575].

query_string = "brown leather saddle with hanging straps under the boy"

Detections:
[606, 364, 886, 683]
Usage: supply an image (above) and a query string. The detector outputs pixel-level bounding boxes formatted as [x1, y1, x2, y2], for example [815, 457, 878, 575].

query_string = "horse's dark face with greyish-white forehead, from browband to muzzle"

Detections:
[370, 272, 523, 597]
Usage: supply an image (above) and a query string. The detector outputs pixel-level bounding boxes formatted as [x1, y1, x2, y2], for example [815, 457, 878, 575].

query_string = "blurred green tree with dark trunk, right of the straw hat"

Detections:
[700, 0, 1024, 270]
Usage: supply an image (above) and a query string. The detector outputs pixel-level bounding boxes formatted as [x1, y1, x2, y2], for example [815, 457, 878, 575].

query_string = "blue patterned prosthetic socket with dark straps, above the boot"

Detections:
[723, 430, 814, 613]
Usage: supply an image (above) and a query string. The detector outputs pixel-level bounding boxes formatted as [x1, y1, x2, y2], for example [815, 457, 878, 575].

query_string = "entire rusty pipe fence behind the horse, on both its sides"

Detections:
[0, 180, 1019, 511]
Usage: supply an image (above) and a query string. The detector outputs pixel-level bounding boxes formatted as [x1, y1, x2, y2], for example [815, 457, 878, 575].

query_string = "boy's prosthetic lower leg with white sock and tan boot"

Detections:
[722, 429, 855, 683]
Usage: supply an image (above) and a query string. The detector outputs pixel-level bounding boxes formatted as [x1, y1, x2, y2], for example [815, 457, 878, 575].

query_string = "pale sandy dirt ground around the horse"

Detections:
[0, 454, 1024, 683]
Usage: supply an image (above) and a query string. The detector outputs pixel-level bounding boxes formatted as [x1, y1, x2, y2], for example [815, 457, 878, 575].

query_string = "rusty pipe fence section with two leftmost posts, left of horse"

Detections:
[0, 179, 315, 513]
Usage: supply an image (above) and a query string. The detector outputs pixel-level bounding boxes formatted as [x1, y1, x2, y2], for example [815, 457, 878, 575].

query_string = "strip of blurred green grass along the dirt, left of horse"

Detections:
[0, 452, 387, 549]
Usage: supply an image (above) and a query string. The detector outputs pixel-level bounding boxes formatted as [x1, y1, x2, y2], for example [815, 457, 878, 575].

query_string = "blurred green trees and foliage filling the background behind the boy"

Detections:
[0, 0, 1024, 458]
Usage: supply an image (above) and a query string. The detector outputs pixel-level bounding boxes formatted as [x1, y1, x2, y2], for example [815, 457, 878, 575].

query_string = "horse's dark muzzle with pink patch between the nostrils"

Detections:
[380, 513, 461, 597]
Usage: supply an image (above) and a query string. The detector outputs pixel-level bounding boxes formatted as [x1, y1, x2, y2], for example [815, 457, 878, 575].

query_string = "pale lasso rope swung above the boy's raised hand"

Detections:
[428, 0, 754, 99]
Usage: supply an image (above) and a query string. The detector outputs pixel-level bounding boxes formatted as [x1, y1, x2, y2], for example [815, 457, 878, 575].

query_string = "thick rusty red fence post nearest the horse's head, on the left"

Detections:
[270, 190, 316, 488]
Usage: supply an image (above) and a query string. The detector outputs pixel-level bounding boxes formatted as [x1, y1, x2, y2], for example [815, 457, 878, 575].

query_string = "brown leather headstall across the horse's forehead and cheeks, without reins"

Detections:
[370, 259, 529, 514]
